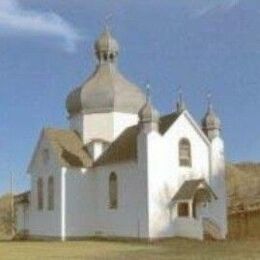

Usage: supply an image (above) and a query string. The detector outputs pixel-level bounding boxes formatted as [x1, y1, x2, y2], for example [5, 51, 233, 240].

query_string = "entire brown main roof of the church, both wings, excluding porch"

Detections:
[44, 113, 178, 168]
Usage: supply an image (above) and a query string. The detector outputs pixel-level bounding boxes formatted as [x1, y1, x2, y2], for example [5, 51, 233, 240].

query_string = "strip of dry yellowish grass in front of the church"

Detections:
[0, 239, 260, 260]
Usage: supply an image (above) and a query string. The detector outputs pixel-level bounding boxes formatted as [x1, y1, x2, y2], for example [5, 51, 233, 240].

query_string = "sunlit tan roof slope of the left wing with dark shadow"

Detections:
[44, 128, 92, 168]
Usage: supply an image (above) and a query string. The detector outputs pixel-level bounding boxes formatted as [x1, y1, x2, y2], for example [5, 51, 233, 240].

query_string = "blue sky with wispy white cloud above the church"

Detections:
[0, 0, 260, 194]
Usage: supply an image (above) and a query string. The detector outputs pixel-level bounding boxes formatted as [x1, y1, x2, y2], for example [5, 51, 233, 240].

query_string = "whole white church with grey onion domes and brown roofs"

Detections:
[15, 29, 227, 241]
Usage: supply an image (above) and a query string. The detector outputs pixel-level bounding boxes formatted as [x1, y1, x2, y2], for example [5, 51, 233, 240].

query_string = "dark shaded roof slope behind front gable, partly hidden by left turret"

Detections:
[94, 113, 179, 166]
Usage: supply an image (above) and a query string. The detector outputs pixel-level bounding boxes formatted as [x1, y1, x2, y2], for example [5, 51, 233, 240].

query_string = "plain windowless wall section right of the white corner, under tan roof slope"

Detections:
[65, 169, 96, 237]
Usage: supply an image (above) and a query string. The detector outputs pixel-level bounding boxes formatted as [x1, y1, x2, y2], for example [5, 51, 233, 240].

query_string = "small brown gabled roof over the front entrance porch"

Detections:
[172, 179, 217, 201]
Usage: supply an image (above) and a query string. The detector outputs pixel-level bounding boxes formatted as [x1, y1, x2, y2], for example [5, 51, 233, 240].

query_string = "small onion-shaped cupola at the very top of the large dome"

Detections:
[95, 28, 119, 60]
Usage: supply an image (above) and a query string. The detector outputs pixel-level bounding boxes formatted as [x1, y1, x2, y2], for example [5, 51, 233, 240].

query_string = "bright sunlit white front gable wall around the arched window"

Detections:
[145, 114, 209, 238]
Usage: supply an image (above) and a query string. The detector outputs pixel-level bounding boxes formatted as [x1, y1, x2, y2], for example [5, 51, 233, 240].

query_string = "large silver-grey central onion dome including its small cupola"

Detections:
[66, 29, 145, 116]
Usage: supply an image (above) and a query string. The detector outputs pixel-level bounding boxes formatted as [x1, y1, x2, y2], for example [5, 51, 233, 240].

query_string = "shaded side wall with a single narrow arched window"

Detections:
[95, 162, 146, 238]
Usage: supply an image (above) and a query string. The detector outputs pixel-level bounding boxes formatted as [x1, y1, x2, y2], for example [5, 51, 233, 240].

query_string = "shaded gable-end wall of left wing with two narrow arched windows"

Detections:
[29, 139, 61, 237]
